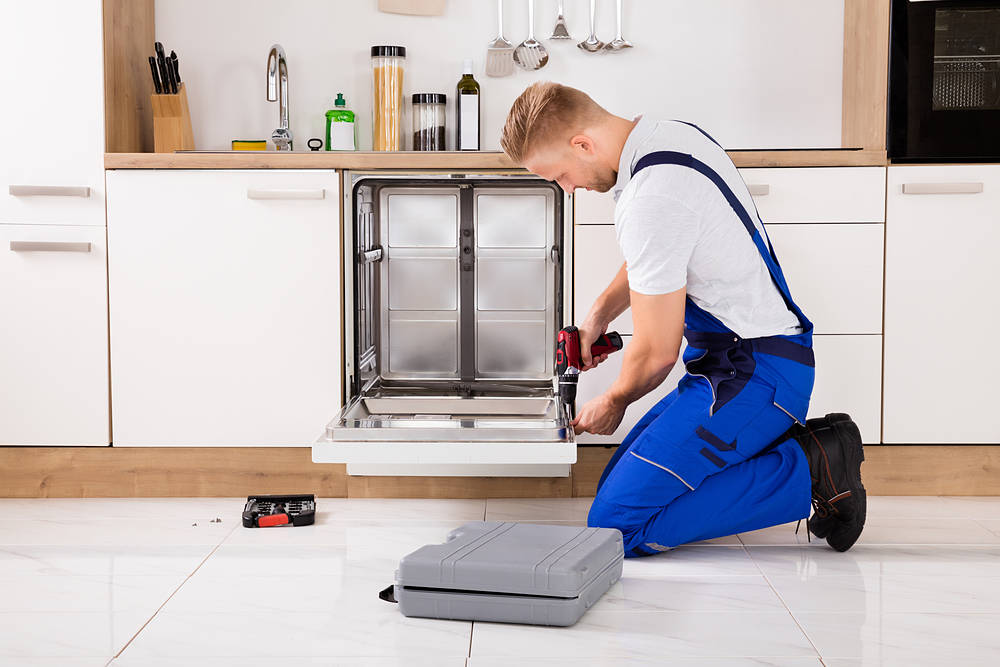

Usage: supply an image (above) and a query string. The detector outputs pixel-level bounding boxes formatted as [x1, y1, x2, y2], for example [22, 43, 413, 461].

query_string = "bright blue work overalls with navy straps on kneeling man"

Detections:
[588, 151, 815, 557]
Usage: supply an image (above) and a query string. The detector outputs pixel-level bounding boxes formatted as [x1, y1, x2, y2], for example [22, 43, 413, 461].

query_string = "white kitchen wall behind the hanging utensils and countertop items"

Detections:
[156, 0, 844, 150]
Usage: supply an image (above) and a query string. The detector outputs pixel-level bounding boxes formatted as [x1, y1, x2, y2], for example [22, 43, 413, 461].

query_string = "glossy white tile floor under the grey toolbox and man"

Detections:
[0, 497, 1000, 667]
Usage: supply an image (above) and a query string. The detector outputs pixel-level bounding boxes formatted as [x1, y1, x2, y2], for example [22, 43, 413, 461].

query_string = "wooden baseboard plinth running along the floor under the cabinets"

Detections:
[0, 445, 1000, 498]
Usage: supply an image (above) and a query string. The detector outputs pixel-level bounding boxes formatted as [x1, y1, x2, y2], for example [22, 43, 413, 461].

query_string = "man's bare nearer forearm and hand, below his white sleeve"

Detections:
[573, 287, 687, 434]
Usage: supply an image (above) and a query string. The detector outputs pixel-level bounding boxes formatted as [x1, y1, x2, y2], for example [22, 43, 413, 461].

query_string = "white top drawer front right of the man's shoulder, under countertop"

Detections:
[740, 167, 886, 223]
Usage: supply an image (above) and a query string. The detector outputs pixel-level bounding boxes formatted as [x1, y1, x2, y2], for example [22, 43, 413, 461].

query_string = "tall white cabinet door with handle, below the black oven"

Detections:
[883, 165, 1000, 444]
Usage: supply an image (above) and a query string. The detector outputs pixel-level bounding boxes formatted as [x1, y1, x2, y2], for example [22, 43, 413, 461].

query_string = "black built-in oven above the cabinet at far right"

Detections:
[887, 0, 1000, 162]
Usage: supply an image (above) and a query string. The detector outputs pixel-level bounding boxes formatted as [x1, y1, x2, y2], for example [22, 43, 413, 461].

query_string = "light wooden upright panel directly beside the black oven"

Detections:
[840, 0, 891, 155]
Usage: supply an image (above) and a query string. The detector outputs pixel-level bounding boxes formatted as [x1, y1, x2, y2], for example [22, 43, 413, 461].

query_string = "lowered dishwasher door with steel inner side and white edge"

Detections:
[313, 387, 576, 464]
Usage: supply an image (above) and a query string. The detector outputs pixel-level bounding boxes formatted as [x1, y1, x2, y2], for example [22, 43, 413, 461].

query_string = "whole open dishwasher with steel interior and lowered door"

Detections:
[313, 172, 576, 475]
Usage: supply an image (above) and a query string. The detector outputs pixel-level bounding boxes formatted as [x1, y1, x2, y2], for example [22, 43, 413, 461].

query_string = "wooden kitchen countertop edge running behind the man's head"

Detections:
[104, 149, 887, 170]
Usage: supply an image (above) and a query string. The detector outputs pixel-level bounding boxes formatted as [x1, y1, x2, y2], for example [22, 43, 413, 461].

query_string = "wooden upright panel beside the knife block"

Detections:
[104, 0, 156, 153]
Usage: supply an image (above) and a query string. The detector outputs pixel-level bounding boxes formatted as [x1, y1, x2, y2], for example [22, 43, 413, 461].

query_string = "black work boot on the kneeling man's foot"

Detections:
[790, 413, 868, 551]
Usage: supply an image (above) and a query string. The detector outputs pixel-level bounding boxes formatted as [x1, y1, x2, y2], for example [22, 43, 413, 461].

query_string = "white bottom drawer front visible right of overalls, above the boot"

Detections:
[809, 336, 882, 444]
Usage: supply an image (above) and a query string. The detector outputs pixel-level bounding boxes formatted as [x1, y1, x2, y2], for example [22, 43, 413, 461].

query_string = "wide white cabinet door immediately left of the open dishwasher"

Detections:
[108, 170, 342, 446]
